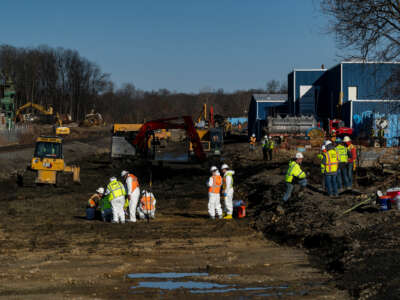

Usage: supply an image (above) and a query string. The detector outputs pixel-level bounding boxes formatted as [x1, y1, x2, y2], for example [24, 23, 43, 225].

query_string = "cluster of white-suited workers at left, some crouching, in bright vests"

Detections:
[88, 171, 156, 223]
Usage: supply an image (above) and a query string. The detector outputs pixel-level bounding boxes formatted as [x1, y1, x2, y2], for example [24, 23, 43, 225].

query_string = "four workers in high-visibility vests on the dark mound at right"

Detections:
[283, 136, 357, 202]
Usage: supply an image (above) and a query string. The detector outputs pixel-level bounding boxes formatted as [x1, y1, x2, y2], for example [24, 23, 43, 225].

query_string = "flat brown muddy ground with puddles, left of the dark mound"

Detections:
[0, 137, 348, 299]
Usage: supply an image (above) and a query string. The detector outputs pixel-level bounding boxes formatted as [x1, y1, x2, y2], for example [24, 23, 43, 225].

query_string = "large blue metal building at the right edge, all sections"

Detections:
[288, 62, 400, 146]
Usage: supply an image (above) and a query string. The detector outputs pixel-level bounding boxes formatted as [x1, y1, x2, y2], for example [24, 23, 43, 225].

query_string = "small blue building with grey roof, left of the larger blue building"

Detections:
[248, 94, 289, 140]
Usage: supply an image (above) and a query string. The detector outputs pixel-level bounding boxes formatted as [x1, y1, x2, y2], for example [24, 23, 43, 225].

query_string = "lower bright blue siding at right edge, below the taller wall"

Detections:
[352, 101, 400, 147]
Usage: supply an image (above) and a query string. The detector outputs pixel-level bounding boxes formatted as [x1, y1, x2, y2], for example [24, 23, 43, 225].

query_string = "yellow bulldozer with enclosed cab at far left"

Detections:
[18, 136, 80, 186]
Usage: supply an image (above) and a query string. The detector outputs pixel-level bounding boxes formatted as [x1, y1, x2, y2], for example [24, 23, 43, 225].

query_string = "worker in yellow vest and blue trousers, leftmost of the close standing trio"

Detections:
[322, 141, 339, 196]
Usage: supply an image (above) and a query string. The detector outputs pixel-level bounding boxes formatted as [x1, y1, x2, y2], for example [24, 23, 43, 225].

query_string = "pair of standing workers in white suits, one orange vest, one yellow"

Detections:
[207, 164, 235, 220]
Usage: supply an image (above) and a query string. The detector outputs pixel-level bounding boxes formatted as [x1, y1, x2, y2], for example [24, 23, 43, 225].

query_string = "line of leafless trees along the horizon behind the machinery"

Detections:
[0, 45, 284, 122]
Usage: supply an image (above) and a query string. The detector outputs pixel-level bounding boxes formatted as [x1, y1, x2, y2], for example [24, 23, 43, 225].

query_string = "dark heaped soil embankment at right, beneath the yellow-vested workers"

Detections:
[228, 144, 400, 299]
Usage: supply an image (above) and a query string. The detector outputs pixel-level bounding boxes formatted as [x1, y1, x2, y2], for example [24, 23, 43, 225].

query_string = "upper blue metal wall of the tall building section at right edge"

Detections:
[342, 63, 400, 102]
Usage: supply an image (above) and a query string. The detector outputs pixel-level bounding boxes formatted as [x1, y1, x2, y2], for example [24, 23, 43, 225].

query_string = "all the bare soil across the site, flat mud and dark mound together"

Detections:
[0, 138, 400, 299]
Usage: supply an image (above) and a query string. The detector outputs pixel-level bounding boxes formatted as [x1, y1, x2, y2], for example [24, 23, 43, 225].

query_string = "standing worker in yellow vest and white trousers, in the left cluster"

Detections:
[105, 177, 126, 224]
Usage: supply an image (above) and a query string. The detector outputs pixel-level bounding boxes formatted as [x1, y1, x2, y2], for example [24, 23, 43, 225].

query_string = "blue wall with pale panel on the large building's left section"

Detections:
[295, 70, 326, 115]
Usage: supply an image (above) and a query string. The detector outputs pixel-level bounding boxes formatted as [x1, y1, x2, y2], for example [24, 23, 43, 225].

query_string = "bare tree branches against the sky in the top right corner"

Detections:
[321, 0, 400, 60]
